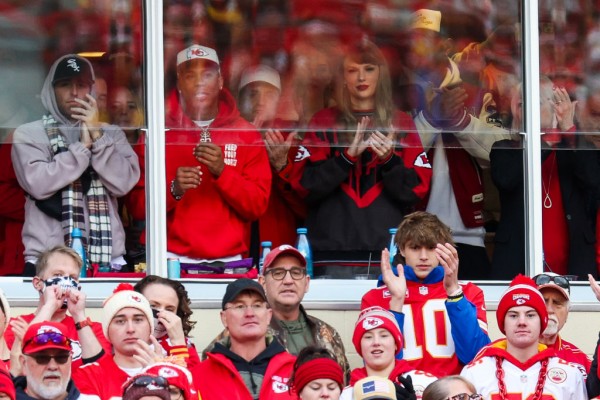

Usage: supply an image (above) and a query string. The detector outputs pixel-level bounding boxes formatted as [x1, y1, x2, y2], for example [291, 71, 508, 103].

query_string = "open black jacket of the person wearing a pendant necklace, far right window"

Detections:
[490, 140, 600, 280]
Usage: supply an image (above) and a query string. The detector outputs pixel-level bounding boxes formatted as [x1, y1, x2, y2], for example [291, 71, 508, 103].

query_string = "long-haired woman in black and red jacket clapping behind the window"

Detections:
[296, 40, 431, 278]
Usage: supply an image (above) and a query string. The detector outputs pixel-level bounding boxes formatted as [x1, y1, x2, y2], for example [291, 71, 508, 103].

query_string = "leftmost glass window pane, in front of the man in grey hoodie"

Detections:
[0, 0, 145, 276]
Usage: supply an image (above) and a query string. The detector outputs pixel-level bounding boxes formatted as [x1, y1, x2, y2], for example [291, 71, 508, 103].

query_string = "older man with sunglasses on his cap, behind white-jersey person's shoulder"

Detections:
[533, 272, 592, 375]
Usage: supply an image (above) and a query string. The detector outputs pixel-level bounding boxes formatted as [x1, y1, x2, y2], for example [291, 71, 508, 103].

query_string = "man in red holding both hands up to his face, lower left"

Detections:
[4, 245, 112, 369]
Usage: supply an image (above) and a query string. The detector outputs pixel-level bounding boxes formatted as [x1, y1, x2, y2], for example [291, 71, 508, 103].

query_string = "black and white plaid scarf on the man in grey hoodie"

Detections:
[42, 115, 112, 265]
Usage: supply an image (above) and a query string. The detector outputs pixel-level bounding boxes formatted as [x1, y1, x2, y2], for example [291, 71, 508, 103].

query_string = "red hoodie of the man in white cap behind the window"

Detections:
[127, 89, 271, 259]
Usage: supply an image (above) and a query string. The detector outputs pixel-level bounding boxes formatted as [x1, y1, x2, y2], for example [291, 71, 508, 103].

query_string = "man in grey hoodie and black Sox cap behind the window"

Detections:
[11, 54, 140, 269]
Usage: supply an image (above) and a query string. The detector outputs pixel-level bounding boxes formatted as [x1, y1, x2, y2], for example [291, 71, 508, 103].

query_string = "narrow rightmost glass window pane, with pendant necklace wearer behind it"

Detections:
[539, 0, 600, 280]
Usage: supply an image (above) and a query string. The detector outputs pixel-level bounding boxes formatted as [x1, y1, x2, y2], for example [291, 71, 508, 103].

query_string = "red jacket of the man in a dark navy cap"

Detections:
[192, 346, 297, 400]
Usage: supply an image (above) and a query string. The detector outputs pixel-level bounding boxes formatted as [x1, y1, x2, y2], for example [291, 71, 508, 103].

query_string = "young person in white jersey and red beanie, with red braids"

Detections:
[461, 275, 588, 400]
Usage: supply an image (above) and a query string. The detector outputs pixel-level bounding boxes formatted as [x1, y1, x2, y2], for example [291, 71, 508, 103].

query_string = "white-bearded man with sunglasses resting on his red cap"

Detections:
[13, 321, 80, 400]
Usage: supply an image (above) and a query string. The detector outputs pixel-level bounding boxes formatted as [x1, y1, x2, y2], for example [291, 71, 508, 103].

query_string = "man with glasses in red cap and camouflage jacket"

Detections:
[203, 244, 350, 378]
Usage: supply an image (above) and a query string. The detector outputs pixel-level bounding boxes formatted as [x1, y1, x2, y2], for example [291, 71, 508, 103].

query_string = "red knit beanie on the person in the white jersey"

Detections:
[496, 274, 548, 333]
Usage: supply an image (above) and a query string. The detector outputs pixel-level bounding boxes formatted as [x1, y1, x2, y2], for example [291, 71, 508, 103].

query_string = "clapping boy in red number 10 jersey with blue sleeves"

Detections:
[361, 211, 490, 377]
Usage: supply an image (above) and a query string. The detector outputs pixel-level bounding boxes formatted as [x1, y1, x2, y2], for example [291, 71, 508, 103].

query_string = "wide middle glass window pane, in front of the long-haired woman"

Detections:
[164, 0, 524, 279]
